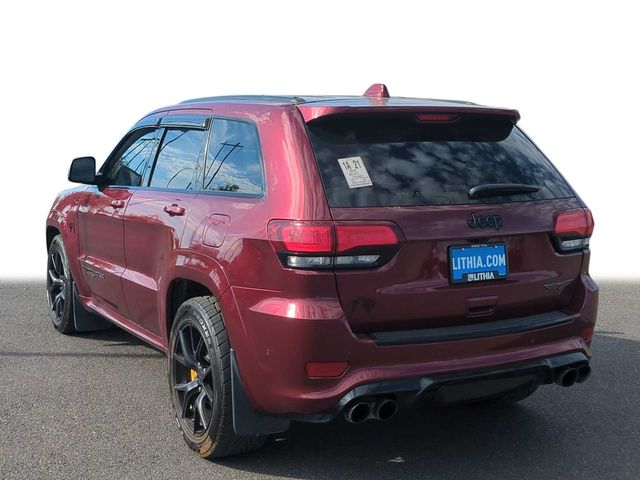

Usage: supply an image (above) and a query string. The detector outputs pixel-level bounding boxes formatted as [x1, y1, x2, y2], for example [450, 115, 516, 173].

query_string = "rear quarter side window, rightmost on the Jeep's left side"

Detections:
[202, 119, 264, 195]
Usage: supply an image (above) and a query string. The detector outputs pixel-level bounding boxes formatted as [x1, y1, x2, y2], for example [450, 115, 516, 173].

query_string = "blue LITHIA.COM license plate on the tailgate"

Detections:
[448, 242, 509, 284]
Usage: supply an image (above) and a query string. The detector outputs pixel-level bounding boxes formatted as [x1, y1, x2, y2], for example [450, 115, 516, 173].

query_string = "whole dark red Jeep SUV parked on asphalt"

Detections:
[46, 84, 598, 457]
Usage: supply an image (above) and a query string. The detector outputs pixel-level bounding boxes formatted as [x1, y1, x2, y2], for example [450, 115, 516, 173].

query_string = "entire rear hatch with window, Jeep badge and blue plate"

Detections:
[307, 111, 583, 332]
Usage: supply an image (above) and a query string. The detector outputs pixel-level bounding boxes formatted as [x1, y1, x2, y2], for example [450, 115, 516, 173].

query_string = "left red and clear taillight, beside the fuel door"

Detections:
[267, 220, 400, 269]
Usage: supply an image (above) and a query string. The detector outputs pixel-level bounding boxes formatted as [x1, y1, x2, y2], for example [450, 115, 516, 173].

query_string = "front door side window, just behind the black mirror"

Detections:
[107, 128, 159, 187]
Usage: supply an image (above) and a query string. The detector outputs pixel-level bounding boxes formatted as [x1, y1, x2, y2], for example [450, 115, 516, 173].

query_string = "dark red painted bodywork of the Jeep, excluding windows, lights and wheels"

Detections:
[47, 90, 597, 414]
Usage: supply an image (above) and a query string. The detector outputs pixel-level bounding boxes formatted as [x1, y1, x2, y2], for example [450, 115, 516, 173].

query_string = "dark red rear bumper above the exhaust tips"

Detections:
[221, 275, 598, 421]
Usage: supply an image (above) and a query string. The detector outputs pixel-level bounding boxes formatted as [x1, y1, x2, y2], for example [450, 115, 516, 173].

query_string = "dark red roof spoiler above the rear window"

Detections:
[297, 105, 520, 125]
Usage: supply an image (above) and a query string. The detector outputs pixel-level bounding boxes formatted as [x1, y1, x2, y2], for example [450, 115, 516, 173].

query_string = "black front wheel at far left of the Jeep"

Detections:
[47, 235, 76, 334]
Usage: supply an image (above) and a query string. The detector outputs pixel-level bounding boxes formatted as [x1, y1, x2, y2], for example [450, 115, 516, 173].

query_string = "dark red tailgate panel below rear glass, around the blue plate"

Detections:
[332, 198, 583, 332]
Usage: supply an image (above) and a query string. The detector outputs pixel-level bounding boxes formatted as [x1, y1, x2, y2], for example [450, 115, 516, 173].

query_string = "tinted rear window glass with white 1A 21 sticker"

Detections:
[307, 114, 573, 207]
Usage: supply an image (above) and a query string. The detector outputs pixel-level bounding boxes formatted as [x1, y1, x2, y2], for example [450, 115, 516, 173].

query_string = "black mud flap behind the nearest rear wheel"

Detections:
[231, 350, 291, 437]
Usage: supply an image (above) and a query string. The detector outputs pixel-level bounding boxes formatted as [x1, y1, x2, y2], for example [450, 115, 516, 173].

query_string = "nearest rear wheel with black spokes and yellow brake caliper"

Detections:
[168, 297, 267, 458]
